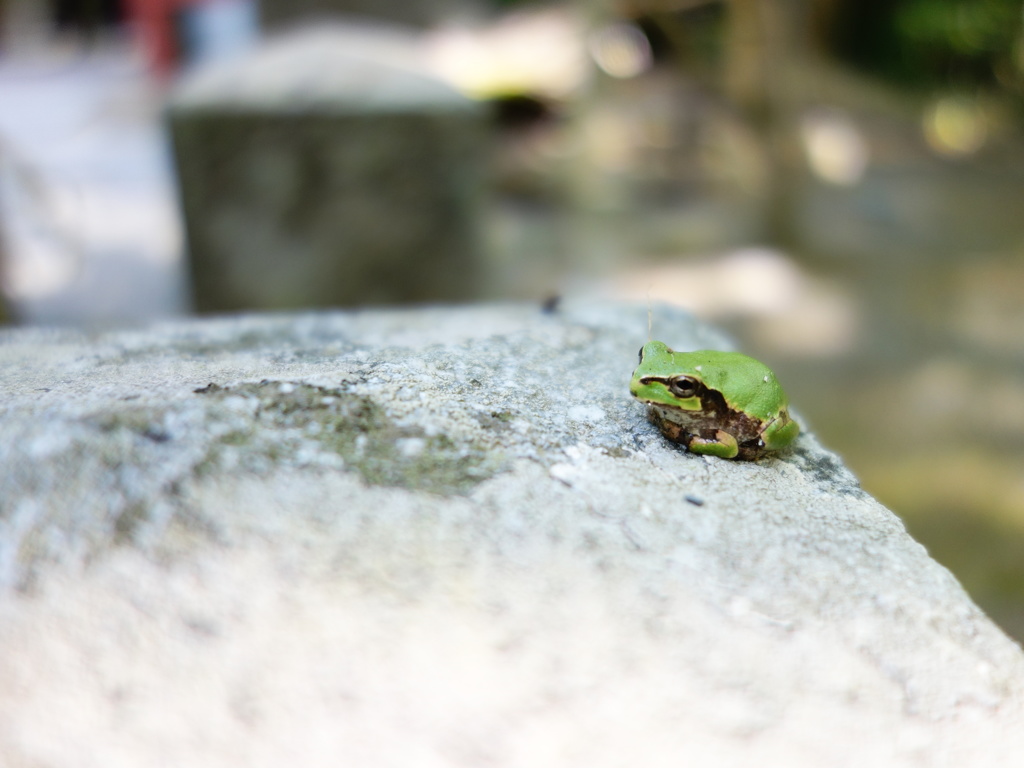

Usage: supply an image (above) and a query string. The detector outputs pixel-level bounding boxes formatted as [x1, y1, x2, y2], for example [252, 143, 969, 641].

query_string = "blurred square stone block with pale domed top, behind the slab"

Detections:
[168, 26, 486, 310]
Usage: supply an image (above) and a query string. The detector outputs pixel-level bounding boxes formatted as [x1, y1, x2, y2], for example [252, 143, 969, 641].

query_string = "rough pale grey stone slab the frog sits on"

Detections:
[0, 305, 1024, 768]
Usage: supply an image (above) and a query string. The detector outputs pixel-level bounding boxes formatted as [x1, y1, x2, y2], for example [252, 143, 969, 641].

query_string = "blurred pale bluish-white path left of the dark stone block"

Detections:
[0, 45, 184, 323]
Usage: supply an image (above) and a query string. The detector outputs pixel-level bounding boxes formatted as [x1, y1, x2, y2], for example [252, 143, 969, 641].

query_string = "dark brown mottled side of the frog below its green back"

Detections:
[644, 376, 764, 461]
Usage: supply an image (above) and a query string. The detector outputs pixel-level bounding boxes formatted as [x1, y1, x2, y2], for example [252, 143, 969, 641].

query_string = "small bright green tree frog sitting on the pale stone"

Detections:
[630, 341, 800, 461]
